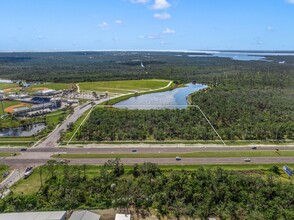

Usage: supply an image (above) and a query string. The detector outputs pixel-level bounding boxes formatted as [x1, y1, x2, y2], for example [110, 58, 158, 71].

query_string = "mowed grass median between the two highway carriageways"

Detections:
[52, 150, 294, 159]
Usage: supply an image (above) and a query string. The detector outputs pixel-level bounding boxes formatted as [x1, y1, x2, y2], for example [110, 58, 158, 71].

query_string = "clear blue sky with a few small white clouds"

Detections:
[0, 0, 294, 51]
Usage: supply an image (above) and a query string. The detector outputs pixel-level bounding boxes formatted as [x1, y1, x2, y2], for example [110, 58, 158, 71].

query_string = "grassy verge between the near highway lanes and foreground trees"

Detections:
[10, 164, 294, 195]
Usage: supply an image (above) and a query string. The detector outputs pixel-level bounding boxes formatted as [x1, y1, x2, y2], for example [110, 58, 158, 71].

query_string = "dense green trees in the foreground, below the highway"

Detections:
[0, 159, 294, 220]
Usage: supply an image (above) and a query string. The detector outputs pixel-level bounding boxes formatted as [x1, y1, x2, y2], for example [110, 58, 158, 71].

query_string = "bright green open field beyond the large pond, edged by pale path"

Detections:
[79, 80, 170, 94]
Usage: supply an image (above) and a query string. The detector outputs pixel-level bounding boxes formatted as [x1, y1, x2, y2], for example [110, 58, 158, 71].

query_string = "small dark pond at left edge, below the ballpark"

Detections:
[0, 123, 46, 137]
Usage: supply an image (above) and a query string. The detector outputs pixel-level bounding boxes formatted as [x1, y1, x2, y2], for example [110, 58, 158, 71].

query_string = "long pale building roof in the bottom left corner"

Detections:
[0, 211, 66, 220]
